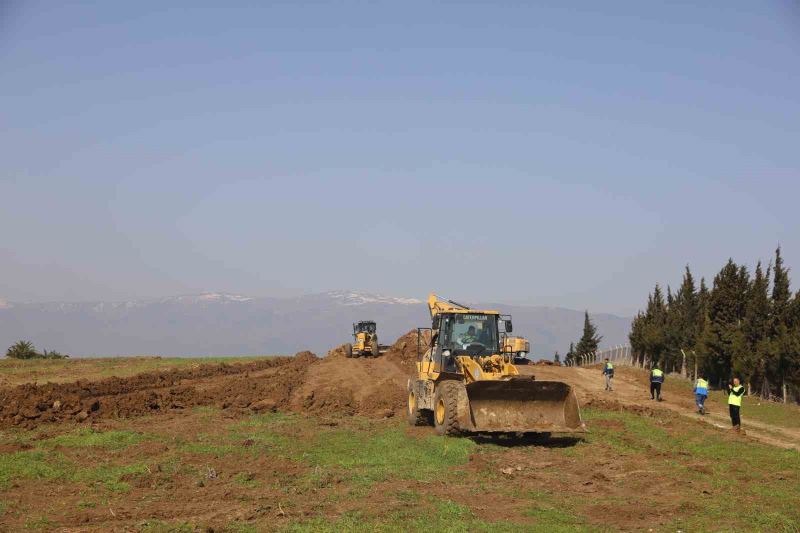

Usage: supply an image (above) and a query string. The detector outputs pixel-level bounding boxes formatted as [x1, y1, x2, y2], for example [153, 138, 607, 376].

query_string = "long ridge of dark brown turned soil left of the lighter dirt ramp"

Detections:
[0, 352, 318, 427]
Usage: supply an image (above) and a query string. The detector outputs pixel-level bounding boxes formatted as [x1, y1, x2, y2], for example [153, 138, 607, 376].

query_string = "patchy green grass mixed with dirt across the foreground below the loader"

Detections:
[0, 396, 800, 533]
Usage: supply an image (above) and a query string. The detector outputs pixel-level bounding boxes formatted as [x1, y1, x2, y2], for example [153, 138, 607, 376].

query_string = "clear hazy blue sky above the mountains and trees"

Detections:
[0, 0, 800, 313]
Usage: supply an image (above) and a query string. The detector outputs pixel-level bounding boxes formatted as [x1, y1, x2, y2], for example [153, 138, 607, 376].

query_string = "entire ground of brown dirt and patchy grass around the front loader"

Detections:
[0, 334, 800, 531]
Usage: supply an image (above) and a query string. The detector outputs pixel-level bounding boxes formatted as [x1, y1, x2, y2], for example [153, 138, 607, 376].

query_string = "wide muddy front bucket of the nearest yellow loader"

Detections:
[466, 378, 585, 433]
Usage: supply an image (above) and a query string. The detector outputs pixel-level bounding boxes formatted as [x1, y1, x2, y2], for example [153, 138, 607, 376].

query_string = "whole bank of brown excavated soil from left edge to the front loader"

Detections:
[0, 331, 424, 428]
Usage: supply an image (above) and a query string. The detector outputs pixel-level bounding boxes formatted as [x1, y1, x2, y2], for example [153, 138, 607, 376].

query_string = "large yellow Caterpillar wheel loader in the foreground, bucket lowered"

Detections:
[408, 294, 585, 435]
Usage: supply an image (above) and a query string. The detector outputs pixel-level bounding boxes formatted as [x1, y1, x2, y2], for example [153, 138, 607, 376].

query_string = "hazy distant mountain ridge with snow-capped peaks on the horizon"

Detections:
[0, 291, 631, 358]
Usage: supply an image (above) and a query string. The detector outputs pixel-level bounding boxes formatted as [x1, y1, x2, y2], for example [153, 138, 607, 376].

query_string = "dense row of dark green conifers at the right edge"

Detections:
[629, 247, 800, 401]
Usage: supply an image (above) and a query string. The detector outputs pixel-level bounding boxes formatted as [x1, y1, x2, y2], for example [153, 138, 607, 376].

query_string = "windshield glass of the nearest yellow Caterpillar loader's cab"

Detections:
[440, 314, 498, 356]
